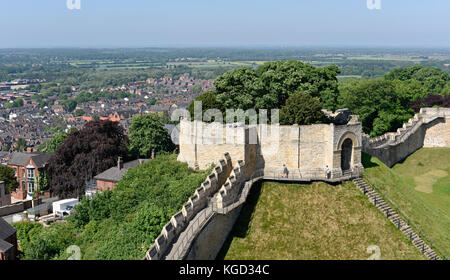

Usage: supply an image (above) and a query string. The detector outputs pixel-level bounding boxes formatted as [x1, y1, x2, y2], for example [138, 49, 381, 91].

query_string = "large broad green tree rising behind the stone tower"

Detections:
[214, 60, 339, 110]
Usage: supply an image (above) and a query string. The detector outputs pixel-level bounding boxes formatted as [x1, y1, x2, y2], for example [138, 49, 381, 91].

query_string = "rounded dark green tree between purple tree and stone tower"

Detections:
[129, 114, 175, 158]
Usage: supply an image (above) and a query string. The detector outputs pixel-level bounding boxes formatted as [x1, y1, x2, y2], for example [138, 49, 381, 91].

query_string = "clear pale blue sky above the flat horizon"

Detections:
[0, 0, 450, 48]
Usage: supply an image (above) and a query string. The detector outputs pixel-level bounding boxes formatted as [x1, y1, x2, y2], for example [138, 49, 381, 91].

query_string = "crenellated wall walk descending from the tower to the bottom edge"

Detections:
[145, 154, 252, 260]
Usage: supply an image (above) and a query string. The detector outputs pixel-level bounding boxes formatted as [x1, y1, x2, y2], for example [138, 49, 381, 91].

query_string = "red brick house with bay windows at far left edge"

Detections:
[8, 152, 52, 200]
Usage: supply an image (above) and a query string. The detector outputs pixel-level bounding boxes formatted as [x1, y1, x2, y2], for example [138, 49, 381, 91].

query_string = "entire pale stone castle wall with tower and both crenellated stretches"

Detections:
[146, 108, 450, 260]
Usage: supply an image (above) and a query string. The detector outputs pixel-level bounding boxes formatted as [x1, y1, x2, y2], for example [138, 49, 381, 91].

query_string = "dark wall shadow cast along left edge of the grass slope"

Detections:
[216, 181, 262, 260]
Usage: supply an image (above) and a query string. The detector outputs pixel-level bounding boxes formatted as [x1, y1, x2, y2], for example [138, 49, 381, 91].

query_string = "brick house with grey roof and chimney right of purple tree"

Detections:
[94, 157, 148, 191]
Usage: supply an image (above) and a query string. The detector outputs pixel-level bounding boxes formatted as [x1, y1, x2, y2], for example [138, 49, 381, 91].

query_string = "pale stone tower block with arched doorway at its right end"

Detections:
[178, 111, 364, 179]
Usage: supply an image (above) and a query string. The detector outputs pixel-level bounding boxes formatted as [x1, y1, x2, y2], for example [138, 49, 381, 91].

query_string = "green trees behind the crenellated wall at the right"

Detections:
[339, 65, 450, 137]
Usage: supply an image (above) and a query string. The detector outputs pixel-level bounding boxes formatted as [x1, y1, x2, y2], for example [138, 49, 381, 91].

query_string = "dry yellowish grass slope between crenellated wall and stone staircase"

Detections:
[218, 182, 425, 260]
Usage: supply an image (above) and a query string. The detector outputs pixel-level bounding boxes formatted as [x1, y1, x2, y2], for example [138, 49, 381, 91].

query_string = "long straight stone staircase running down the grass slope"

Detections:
[353, 177, 440, 260]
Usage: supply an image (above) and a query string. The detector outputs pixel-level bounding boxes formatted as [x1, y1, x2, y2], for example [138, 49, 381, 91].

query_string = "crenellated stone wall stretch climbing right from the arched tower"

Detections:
[362, 108, 450, 167]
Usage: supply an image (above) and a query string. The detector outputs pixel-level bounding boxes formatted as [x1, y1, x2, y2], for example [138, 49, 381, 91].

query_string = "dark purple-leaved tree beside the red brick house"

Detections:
[47, 121, 128, 198]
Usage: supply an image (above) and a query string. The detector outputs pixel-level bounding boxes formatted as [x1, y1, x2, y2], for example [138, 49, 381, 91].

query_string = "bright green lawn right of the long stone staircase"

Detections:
[363, 148, 450, 256]
